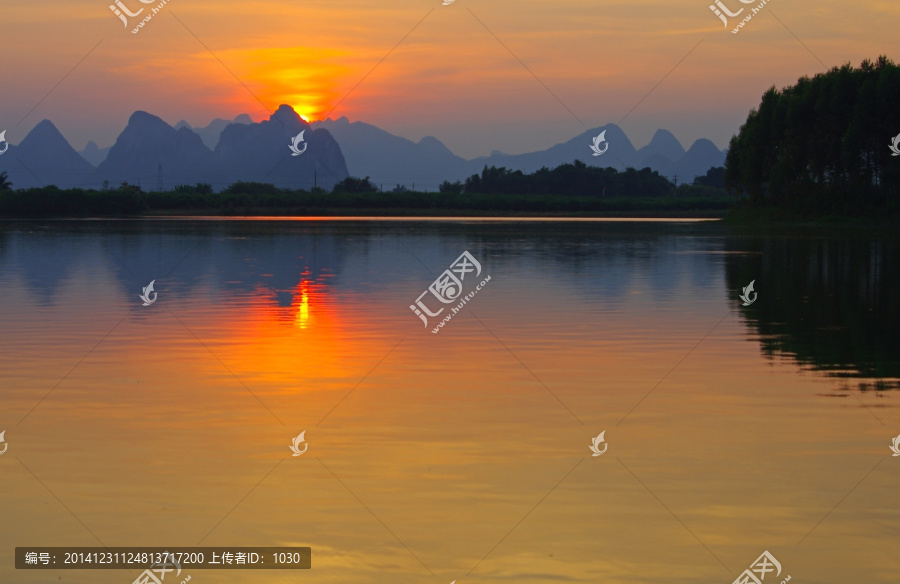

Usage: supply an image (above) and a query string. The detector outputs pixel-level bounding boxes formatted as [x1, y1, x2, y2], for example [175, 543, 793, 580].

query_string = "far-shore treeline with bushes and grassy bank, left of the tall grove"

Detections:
[0, 161, 735, 219]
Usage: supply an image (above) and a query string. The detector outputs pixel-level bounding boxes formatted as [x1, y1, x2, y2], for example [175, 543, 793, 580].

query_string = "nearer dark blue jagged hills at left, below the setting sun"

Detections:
[0, 105, 348, 191]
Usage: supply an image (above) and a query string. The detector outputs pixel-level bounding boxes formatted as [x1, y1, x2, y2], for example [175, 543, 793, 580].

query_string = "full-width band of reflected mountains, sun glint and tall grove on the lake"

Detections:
[0, 220, 900, 391]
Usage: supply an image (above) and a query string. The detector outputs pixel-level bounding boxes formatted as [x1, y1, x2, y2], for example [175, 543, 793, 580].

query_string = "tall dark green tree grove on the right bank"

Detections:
[725, 56, 900, 213]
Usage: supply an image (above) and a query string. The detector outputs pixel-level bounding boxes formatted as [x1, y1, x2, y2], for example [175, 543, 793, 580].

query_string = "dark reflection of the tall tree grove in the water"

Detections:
[725, 232, 900, 391]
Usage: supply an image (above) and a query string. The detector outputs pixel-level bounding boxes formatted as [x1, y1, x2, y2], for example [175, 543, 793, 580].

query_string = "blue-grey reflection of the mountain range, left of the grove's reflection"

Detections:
[0, 221, 718, 306]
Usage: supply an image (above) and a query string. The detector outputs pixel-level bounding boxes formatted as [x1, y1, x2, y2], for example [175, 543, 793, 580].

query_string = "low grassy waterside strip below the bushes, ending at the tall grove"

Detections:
[0, 190, 734, 219]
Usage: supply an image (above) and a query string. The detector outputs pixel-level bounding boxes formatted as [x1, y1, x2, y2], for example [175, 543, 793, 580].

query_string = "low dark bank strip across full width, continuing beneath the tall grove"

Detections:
[0, 179, 900, 226]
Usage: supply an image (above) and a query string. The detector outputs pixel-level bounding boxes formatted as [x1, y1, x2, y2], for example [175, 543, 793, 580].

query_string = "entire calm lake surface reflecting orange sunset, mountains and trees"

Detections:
[0, 220, 900, 584]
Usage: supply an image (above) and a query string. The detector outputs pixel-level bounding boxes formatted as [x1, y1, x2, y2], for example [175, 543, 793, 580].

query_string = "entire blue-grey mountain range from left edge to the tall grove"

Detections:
[0, 105, 725, 190]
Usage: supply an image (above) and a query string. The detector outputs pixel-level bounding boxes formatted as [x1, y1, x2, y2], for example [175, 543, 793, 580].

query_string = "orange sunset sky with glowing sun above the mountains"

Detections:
[0, 0, 900, 158]
